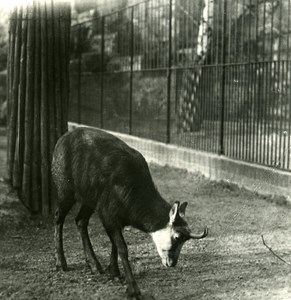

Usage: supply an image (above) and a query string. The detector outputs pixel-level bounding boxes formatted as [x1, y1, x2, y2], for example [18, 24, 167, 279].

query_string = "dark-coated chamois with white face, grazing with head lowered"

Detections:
[52, 128, 208, 299]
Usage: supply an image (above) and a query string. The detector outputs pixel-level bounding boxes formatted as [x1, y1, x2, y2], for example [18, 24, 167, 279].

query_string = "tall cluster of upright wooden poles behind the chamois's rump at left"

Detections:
[7, 0, 70, 215]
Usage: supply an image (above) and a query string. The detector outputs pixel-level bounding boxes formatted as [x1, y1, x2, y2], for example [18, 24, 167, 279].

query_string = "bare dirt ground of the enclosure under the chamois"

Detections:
[0, 125, 291, 300]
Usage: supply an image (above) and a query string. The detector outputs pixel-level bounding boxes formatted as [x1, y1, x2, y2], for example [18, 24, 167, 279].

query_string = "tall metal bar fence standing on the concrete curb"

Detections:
[70, 0, 291, 170]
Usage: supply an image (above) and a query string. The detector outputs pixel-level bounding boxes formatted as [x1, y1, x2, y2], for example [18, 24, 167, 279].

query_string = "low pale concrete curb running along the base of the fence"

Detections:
[69, 123, 291, 203]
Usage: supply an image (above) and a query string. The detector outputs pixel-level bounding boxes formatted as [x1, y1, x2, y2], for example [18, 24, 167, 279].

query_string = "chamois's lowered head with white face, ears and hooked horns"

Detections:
[152, 202, 208, 267]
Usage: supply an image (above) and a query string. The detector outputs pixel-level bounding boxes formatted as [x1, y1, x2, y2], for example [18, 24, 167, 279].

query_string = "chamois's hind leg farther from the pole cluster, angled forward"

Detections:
[75, 205, 103, 274]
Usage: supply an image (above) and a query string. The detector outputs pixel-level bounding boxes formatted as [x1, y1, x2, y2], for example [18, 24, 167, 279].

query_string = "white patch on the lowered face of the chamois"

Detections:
[151, 224, 184, 267]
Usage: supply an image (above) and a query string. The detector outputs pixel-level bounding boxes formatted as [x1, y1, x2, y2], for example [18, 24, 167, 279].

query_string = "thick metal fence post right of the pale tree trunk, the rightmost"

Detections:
[219, 0, 228, 155]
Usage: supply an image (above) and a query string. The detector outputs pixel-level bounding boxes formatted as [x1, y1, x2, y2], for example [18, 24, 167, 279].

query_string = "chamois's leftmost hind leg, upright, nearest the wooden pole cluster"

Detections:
[55, 197, 75, 271]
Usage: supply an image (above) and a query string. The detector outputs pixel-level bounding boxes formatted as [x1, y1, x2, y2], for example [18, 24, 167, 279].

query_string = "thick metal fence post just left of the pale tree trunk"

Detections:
[166, 0, 172, 144]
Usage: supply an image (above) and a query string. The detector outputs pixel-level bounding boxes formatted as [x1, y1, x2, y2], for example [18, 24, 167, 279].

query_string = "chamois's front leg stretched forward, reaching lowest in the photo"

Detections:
[111, 230, 142, 299]
